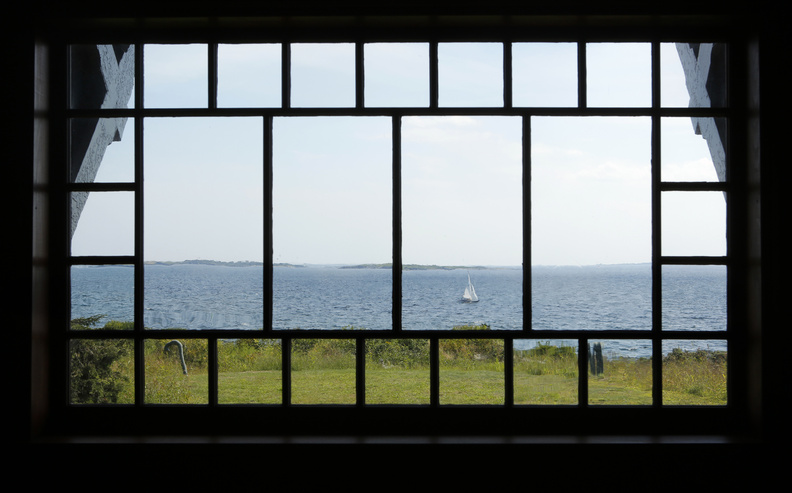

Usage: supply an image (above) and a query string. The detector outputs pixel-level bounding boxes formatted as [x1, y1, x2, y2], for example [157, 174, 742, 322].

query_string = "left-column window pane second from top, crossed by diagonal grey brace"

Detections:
[70, 118, 135, 183]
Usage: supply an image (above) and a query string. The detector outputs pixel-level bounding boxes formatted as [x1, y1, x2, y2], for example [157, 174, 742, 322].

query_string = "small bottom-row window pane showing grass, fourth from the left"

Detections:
[291, 339, 356, 404]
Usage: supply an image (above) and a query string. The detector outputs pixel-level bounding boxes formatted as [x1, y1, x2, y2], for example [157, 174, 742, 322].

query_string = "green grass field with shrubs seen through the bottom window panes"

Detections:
[71, 324, 727, 405]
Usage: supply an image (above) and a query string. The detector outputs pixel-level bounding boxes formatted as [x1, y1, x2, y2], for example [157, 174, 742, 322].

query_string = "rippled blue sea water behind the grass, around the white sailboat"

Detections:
[71, 264, 726, 355]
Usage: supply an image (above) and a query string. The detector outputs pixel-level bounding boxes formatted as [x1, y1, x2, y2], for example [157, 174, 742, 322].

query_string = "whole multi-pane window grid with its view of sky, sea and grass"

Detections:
[66, 40, 729, 407]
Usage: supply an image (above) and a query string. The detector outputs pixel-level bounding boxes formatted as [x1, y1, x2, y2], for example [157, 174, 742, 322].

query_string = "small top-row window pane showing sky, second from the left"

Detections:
[143, 44, 209, 108]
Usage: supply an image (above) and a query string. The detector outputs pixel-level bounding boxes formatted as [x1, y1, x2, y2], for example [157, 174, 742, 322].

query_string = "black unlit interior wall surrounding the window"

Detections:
[9, 0, 790, 486]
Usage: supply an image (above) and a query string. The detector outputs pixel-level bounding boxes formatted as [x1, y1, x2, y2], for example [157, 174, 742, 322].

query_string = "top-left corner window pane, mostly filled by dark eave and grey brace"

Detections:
[69, 44, 135, 109]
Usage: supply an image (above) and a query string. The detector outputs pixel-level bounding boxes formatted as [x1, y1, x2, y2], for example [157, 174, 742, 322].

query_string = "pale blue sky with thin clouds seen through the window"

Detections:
[72, 43, 725, 266]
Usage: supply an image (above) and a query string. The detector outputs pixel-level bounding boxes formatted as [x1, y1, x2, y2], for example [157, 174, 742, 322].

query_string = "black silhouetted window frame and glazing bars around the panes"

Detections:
[35, 13, 754, 436]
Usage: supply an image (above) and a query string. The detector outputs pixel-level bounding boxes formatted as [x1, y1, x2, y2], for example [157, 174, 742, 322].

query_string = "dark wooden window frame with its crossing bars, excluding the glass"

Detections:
[34, 13, 758, 437]
